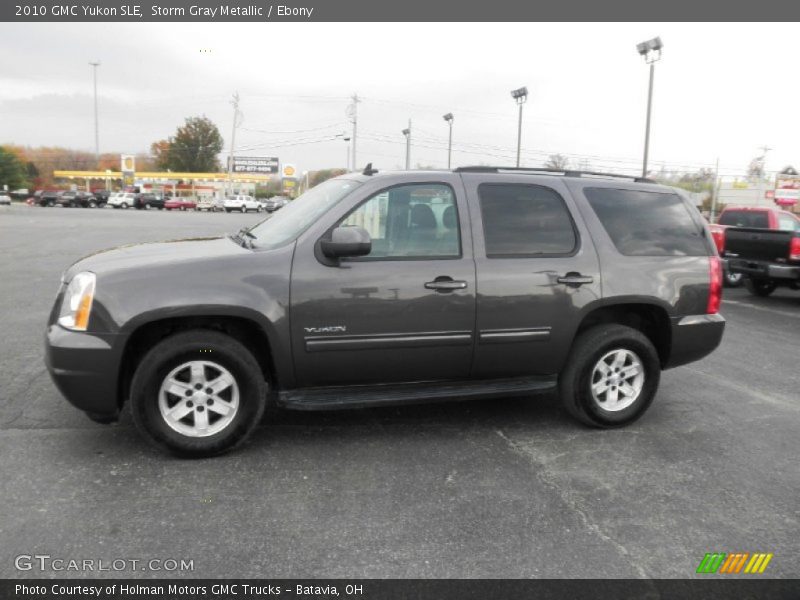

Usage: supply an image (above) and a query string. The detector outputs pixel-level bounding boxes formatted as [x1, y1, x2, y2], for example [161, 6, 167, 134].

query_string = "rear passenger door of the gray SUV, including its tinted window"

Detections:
[463, 173, 600, 379]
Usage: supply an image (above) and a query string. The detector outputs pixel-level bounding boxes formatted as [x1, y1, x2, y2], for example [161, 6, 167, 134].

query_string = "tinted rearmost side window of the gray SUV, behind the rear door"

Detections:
[584, 188, 708, 256]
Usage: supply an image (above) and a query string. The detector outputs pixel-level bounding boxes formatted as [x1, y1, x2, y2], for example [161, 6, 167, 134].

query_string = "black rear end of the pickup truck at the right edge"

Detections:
[725, 221, 800, 296]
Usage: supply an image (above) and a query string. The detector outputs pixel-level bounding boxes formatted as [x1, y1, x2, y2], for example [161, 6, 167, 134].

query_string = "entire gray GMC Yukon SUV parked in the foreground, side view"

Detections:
[46, 167, 725, 456]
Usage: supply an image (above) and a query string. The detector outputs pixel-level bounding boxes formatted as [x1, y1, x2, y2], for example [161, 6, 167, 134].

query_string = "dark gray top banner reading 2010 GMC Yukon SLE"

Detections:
[0, 0, 800, 21]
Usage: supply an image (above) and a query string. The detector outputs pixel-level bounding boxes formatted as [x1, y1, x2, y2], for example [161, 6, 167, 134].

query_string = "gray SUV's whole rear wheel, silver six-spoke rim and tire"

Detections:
[559, 324, 661, 427]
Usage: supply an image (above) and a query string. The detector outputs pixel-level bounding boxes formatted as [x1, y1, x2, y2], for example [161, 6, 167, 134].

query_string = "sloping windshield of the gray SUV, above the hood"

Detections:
[250, 179, 361, 249]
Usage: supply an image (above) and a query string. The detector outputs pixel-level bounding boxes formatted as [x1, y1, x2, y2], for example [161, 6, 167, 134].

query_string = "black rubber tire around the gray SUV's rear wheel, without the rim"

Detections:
[558, 324, 661, 428]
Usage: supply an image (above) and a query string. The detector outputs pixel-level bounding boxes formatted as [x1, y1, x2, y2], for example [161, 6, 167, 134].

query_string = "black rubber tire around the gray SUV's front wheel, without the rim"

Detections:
[130, 329, 267, 458]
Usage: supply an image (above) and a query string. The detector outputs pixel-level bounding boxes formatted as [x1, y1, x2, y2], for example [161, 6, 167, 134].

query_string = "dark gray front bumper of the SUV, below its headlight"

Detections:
[45, 324, 121, 422]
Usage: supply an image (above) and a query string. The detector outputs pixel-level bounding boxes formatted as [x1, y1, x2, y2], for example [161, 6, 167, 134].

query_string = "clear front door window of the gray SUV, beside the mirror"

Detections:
[340, 183, 461, 260]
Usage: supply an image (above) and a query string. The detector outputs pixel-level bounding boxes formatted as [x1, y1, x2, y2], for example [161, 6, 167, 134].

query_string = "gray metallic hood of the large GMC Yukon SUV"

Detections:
[63, 237, 251, 281]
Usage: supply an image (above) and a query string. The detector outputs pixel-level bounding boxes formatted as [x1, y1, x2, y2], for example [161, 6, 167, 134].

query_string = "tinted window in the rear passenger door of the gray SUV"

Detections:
[478, 183, 577, 258]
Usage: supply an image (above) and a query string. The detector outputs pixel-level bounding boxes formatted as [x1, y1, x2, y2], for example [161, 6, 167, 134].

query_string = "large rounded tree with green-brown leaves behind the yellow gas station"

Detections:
[150, 116, 223, 173]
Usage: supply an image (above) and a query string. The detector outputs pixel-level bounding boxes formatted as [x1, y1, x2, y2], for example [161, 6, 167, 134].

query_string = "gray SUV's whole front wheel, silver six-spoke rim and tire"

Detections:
[130, 330, 267, 458]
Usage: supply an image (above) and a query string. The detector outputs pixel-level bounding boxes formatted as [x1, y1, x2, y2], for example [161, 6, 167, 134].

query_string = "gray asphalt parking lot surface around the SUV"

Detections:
[0, 206, 800, 578]
